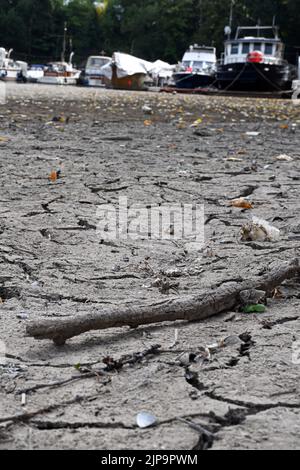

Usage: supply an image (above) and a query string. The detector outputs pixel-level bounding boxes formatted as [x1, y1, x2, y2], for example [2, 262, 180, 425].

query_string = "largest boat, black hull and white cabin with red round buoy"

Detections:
[217, 26, 297, 92]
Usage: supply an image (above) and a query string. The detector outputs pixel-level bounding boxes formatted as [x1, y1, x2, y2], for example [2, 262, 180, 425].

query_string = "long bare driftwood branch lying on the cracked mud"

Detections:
[27, 259, 300, 345]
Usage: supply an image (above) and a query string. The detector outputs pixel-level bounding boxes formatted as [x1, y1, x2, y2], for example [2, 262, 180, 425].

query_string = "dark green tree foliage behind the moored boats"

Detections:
[0, 0, 300, 62]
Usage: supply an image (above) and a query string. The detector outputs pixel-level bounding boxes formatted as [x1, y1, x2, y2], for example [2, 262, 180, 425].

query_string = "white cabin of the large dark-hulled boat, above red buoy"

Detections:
[222, 26, 284, 65]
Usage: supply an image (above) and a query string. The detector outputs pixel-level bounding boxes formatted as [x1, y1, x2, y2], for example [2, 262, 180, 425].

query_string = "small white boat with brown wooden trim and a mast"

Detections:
[37, 52, 81, 85]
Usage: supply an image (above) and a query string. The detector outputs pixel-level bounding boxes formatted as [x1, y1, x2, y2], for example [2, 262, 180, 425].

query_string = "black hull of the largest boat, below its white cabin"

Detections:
[217, 63, 297, 92]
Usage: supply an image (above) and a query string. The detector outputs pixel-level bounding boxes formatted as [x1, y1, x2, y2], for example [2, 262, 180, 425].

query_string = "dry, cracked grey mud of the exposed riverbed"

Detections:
[0, 85, 300, 450]
